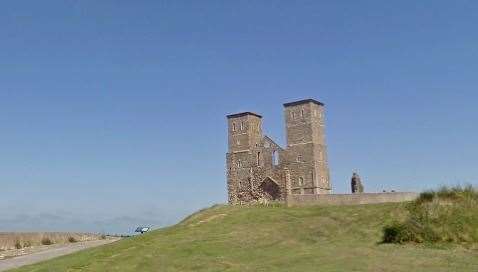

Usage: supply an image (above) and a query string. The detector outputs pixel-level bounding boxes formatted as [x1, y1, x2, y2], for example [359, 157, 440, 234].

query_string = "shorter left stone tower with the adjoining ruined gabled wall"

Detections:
[226, 113, 286, 204]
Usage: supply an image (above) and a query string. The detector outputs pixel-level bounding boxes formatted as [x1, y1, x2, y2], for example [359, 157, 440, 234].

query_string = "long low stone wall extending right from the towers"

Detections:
[286, 193, 419, 207]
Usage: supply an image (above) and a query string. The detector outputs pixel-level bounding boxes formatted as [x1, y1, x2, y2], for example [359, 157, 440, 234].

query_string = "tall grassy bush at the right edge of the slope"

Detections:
[383, 186, 478, 243]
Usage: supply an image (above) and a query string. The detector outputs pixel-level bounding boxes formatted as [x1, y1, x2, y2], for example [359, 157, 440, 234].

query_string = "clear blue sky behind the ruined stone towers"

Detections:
[0, 0, 478, 232]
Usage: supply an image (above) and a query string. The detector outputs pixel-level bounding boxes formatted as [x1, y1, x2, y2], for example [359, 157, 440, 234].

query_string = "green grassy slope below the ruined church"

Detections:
[11, 204, 478, 272]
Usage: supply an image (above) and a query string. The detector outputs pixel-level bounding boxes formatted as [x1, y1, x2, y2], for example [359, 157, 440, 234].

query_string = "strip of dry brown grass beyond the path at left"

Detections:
[0, 232, 100, 251]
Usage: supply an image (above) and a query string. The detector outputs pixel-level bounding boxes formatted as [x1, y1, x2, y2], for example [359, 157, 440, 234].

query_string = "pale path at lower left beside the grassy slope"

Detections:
[0, 239, 118, 271]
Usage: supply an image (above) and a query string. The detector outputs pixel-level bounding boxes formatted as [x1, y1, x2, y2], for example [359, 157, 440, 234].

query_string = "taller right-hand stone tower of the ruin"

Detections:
[284, 99, 331, 194]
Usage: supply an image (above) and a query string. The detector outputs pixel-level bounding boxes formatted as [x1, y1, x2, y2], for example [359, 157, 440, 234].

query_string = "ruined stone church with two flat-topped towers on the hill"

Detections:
[226, 99, 332, 204]
